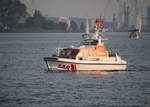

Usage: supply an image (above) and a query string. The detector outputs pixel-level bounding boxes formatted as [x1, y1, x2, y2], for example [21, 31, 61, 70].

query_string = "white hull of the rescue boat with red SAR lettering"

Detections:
[45, 59, 127, 72]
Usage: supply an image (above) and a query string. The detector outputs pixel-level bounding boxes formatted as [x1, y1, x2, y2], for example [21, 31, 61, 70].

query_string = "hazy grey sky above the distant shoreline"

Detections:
[22, 0, 150, 20]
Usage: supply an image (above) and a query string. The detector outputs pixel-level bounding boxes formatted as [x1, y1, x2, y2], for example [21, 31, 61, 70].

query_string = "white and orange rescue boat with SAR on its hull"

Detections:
[44, 19, 127, 72]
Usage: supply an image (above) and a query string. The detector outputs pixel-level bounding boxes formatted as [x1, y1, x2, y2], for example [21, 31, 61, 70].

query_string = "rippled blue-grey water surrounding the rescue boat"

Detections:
[0, 33, 150, 107]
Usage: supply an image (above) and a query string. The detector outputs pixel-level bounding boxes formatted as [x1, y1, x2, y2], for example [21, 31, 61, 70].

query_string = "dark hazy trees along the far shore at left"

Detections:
[0, 0, 85, 32]
